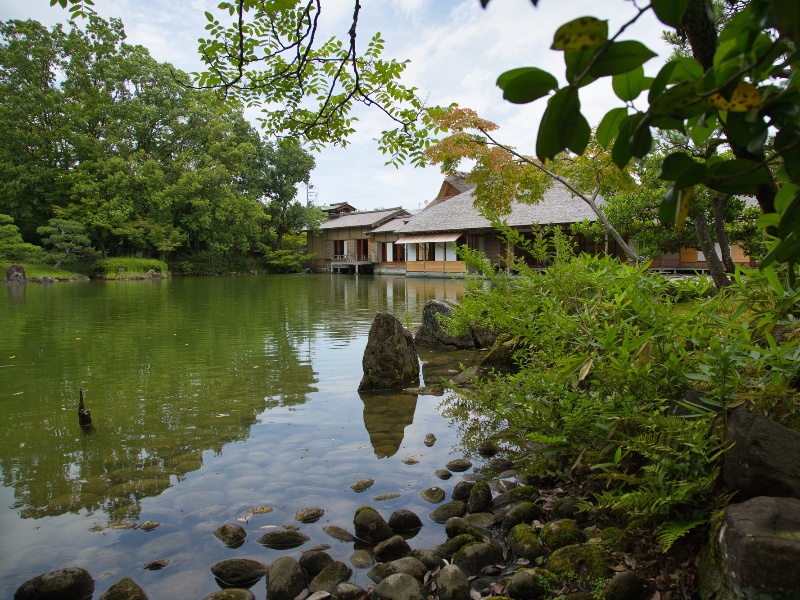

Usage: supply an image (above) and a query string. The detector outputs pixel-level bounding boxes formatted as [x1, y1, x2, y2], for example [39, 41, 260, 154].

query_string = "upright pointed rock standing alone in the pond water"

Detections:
[358, 313, 419, 391]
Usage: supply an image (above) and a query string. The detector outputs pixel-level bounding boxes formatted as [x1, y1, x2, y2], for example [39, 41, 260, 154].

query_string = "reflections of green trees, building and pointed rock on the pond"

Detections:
[0, 276, 461, 523]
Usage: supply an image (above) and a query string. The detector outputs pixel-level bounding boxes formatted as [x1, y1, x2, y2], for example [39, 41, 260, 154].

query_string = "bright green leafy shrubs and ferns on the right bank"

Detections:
[449, 226, 800, 542]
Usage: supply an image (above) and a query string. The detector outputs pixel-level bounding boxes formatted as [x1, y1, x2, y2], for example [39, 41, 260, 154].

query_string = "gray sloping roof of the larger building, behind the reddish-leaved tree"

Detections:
[398, 182, 602, 234]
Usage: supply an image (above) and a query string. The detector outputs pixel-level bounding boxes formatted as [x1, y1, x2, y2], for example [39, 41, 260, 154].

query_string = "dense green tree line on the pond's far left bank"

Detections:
[0, 15, 318, 270]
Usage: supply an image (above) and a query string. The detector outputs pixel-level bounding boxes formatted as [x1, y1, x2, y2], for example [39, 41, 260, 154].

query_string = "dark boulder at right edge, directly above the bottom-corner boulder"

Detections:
[722, 407, 800, 501]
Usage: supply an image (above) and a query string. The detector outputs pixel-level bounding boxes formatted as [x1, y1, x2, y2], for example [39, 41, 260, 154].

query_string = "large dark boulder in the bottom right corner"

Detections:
[698, 496, 800, 600]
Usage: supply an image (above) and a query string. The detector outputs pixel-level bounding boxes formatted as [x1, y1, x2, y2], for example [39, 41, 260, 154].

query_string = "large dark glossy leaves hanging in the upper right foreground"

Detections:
[488, 0, 800, 266]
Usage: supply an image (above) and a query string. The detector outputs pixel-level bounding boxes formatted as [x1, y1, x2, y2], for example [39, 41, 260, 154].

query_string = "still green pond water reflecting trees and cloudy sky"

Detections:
[0, 275, 479, 599]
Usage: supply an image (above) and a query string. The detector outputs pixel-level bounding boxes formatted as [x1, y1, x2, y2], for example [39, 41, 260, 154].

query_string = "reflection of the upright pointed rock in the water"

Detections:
[361, 394, 417, 458]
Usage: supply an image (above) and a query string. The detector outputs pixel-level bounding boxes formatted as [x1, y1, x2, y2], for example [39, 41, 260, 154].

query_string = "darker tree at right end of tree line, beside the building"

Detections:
[253, 139, 315, 250]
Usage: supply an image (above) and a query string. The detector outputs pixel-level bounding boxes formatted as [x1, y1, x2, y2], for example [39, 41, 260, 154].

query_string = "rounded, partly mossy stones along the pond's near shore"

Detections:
[14, 445, 658, 600]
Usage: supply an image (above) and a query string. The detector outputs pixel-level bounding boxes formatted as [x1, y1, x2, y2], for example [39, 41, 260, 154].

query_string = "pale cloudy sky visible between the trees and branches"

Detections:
[0, 0, 669, 210]
